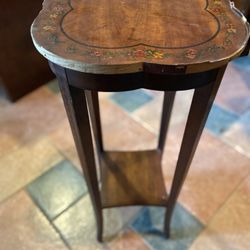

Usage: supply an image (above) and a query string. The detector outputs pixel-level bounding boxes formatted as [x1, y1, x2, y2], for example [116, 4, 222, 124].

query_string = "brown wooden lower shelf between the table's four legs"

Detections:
[101, 150, 167, 208]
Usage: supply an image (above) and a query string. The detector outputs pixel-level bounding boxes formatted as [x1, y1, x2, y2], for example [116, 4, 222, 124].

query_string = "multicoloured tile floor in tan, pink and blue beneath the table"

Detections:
[0, 57, 250, 250]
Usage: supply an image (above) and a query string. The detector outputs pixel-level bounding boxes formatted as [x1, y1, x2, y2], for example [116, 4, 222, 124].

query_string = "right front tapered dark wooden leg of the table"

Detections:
[164, 67, 226, 237]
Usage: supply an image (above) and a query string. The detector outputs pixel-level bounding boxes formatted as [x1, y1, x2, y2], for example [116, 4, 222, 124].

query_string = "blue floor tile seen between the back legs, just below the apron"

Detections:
[110, 89, 153, 112]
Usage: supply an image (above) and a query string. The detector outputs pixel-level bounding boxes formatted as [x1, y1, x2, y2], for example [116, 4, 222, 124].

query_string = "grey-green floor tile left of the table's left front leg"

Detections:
[27, 161, 87, 220]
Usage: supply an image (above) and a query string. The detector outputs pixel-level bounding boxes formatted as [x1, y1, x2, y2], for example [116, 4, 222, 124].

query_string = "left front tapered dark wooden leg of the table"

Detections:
[53, 65, 103, 241]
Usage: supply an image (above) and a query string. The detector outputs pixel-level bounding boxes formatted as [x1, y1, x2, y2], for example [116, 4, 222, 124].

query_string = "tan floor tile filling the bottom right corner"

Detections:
[190, 176, 250, 250]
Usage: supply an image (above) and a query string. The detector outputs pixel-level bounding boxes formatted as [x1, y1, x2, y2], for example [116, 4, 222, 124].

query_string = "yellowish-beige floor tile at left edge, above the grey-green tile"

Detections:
[0, 138, 62, 201]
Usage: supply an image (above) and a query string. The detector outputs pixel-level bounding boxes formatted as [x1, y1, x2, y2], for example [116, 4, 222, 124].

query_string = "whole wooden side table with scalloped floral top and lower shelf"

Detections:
[31, 0, 249, 241]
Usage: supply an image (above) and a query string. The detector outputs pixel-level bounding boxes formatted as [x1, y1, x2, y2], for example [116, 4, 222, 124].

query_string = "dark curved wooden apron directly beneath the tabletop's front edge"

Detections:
[63, 65, 220, 92]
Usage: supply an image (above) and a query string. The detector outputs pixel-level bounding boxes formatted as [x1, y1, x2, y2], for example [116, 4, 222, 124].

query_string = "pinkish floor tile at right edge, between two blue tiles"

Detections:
[215, 58, 250, 114]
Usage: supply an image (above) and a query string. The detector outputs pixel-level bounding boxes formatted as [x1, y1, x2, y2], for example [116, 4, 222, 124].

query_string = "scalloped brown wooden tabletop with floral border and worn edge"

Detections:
[31, 0, 249, 74]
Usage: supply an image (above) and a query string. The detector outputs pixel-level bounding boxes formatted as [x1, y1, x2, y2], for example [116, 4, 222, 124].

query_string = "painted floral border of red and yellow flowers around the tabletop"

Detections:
[42, 0, 237, 60]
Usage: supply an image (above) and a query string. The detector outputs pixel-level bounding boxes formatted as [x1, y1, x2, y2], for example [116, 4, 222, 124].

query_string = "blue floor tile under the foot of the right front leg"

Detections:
[132, 204, 203, 250]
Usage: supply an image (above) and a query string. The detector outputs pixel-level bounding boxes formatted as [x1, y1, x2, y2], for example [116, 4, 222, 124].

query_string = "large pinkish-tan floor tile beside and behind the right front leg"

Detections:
[163, 127, 250, 224]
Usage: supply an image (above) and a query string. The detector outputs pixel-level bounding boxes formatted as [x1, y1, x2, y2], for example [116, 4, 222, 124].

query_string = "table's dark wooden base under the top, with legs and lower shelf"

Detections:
[50, 63, 229, 241]
